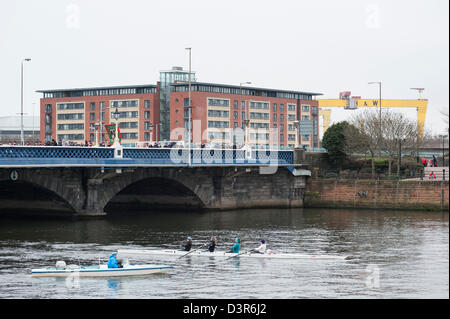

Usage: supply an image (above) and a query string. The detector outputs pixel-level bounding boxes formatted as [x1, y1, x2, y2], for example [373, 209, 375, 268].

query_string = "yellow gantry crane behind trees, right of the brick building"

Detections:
[318, 88, 428, 136]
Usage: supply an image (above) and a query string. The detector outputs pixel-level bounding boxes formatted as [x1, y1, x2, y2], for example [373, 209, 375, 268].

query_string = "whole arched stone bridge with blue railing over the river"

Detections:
[0, 146, 311, 217]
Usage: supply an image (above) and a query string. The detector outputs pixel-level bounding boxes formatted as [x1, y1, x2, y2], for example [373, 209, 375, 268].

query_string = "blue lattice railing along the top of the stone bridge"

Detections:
[0, 146, 294, 167]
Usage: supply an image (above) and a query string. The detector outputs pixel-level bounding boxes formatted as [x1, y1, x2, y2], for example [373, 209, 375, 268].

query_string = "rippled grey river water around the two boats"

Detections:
[0, 209, 449, 299]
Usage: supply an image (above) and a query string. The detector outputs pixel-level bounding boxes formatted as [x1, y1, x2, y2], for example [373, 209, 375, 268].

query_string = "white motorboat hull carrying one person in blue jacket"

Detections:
[31, 265, 173, 277]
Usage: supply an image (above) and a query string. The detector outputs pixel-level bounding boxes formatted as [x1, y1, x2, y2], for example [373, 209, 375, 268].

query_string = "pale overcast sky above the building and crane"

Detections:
[0, 0, 449, 134]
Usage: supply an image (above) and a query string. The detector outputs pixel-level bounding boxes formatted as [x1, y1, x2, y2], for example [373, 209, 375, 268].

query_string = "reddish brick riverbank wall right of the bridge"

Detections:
[304, 178, 449, 211]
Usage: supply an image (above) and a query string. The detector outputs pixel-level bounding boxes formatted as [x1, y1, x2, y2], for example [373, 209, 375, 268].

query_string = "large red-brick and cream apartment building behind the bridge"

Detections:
[38, 67, 320, 149]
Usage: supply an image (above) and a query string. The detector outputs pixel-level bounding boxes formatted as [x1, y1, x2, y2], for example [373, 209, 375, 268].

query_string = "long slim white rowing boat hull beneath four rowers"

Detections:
[117, 249, 347, 260]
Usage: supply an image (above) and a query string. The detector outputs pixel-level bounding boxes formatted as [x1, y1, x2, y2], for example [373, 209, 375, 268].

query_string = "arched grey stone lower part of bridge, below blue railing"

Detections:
[0, 166, 306, 216]
